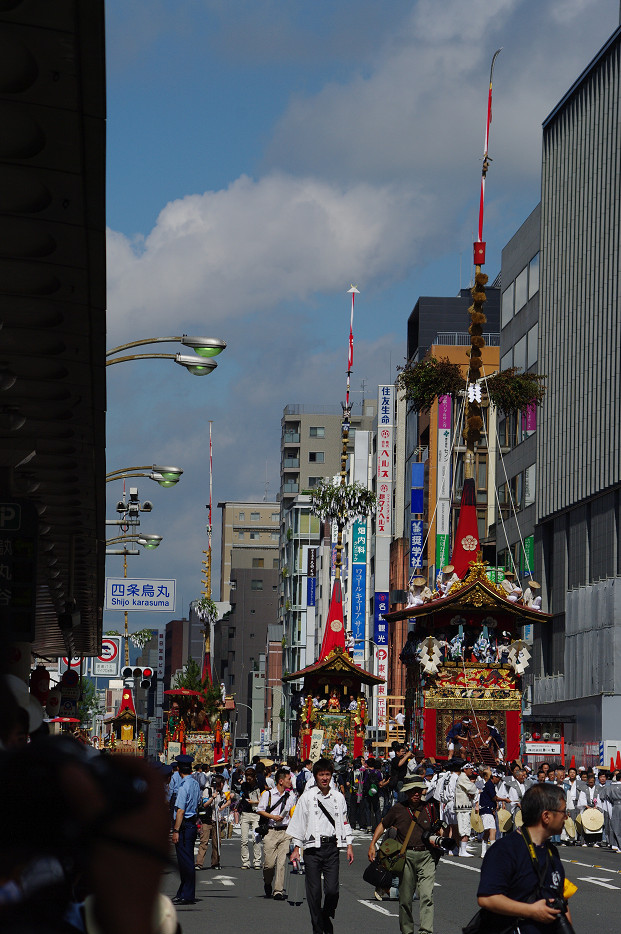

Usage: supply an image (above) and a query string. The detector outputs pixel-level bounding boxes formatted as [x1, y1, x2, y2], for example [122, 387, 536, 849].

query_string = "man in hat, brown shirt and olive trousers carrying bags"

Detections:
[368, 775, 443, 934]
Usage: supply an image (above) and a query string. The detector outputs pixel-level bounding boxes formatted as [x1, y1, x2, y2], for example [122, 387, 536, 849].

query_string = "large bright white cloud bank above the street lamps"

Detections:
[108, 173, 429, 339]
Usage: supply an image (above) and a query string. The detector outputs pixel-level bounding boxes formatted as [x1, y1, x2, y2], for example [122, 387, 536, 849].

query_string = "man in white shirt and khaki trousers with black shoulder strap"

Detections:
[257, 769, 296, 902]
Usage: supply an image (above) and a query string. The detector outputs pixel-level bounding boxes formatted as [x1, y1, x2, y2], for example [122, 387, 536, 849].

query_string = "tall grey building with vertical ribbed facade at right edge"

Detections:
[533, 28, 621, 748]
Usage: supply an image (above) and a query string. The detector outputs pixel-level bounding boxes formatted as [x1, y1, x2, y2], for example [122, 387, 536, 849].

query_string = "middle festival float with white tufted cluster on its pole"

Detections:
[282, 285, 384, 759]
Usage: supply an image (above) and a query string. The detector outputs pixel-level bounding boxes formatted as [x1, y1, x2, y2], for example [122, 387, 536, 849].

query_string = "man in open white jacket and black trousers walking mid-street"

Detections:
[287, 759, 354, 934]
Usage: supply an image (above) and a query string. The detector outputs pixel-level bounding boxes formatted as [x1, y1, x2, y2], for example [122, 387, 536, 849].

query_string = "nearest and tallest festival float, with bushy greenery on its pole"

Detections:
[386, 50, 550, 762]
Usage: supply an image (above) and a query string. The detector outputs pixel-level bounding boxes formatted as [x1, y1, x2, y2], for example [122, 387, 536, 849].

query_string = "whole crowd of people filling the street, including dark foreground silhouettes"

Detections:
[0, 672, 621, 934]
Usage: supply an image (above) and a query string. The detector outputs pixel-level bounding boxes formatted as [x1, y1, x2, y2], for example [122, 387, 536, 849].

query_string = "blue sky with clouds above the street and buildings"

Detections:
[104, 0, 619, 629]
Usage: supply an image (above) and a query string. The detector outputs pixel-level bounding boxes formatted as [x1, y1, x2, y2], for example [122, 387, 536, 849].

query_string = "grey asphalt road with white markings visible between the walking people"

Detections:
[162, 834, 621, 934]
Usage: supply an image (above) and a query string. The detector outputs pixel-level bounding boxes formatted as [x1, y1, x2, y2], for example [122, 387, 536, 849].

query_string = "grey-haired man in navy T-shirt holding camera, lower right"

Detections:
[474, 783, 574, 934]
